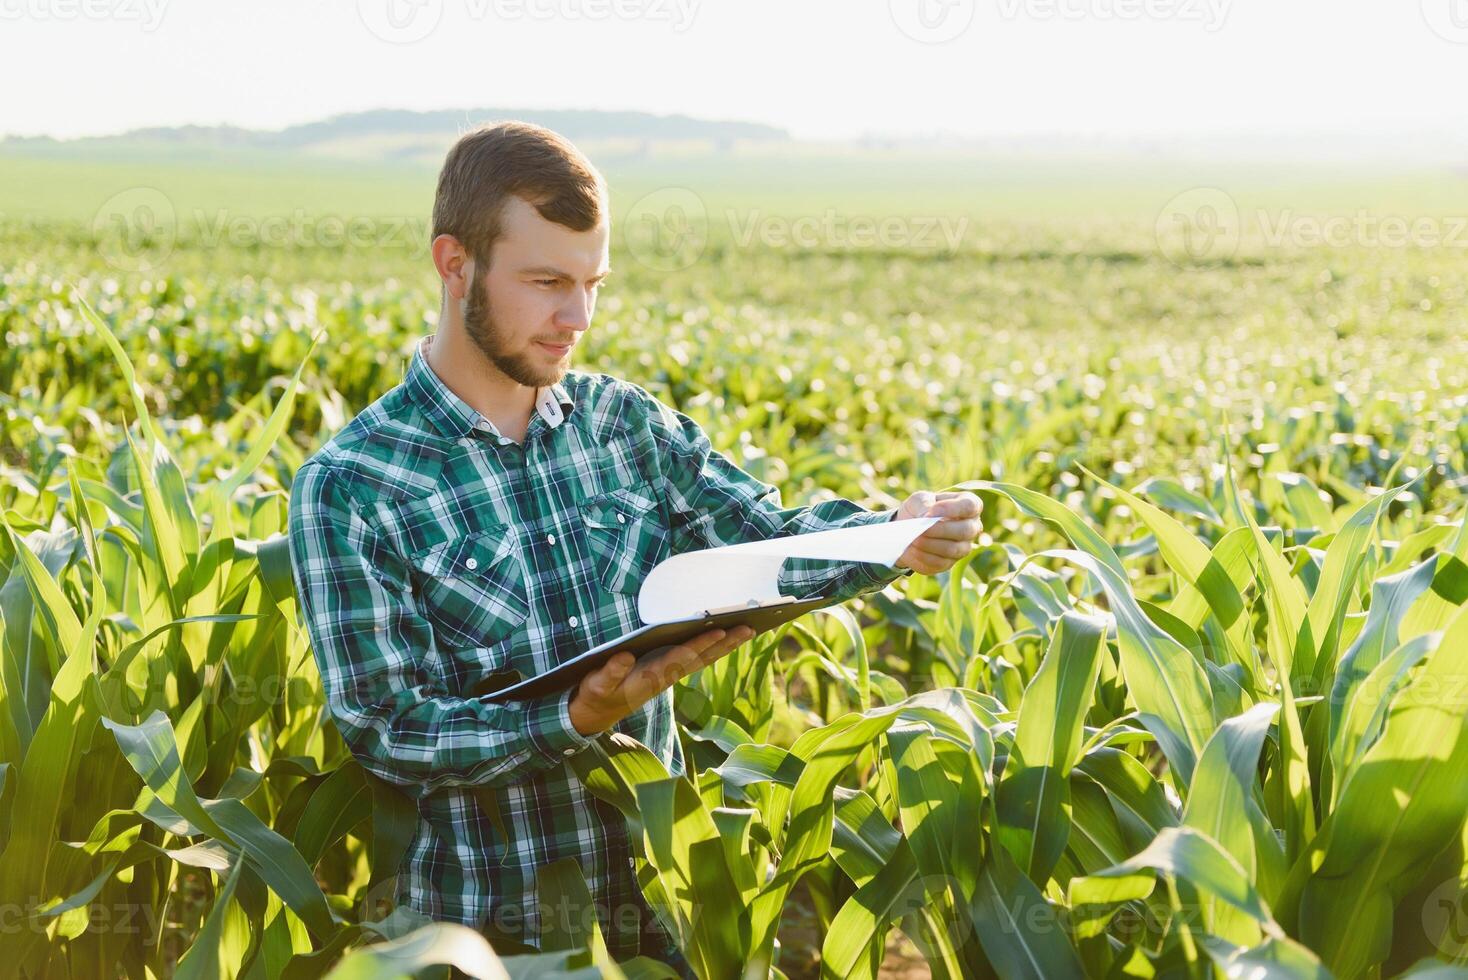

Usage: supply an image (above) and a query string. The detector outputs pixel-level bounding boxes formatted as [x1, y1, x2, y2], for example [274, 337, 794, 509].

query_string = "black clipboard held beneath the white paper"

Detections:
[482, 596, 838, 704]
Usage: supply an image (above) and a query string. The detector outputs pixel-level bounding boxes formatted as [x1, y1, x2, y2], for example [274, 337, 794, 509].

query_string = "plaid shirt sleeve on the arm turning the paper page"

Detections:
[643, 392, 912, 600]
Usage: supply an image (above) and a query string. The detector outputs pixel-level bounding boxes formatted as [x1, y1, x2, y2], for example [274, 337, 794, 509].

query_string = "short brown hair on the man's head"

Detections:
[430, 122, 606, 270]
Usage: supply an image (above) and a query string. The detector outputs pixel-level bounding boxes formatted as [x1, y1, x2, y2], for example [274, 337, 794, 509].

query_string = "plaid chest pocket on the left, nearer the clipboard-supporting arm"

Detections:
[408, 524, 530, 654]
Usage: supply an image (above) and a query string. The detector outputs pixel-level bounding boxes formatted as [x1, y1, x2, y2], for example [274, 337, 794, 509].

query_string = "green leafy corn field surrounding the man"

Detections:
[0, 211, 1468, 980]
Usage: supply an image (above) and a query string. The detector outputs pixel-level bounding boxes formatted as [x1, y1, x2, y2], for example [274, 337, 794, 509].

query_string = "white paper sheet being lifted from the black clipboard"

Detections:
[637, 518, 938, 624]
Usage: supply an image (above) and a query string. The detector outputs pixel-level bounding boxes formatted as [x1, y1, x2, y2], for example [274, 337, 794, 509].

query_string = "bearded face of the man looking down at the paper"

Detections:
[464, 198, 611, 387]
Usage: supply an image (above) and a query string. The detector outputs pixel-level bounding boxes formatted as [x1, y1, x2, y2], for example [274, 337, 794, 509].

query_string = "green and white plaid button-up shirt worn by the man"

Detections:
[289, 337, 909, 955]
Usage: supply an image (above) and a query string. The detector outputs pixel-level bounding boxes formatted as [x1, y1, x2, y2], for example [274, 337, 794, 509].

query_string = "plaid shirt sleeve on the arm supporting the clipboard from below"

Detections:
[289, 461, 590, 798]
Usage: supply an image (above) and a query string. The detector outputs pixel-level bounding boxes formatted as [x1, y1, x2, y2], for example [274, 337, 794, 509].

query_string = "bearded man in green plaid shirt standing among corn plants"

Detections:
[291, 123, 979, 958]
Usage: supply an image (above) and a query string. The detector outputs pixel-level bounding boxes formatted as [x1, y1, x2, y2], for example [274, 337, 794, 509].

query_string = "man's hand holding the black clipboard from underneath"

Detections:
[570, 626, 755, 735]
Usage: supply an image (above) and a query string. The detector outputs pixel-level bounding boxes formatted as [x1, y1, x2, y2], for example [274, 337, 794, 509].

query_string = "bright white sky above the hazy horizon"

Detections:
[0, 0, 1468, 139]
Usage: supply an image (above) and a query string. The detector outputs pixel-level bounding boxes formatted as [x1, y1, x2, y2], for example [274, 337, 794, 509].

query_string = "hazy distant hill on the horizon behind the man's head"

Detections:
[0, 109, 790, 166]
